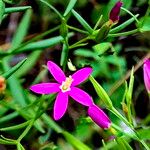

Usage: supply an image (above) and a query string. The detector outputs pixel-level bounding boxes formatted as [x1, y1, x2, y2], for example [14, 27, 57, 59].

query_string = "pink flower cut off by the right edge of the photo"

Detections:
[143, 59, 150, 93]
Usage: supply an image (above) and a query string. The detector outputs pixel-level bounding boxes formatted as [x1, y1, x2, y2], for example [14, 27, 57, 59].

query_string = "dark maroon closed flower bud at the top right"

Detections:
[109, 1, 123, 23]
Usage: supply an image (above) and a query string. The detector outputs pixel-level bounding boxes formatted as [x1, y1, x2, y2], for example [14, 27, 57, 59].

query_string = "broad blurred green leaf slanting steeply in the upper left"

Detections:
[9, 9, 32, 51]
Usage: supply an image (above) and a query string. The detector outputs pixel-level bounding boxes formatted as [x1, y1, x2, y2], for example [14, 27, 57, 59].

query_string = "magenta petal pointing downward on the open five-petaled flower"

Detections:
[54, 92, 68, 120]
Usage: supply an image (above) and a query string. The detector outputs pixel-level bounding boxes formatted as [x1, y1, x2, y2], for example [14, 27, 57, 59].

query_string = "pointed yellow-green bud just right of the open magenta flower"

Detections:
[89, 76, 113, 108]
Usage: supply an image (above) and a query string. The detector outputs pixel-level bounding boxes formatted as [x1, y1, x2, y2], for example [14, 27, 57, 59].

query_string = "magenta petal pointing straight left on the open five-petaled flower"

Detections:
[30, 83, 60, 94]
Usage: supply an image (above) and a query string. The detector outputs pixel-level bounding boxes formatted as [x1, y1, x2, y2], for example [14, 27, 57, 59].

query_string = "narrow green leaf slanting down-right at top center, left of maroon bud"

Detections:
[72, 10, 93, 34]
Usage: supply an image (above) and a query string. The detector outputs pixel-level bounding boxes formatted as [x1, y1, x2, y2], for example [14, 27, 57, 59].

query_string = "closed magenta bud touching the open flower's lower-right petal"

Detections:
[88, 104, 111, 128]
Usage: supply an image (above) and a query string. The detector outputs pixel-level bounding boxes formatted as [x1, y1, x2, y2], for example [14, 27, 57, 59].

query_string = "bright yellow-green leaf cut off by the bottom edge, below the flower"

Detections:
[62, 131, 91, 150]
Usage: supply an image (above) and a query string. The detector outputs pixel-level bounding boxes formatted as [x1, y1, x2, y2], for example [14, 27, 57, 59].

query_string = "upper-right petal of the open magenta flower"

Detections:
[72, 67, 93, 86]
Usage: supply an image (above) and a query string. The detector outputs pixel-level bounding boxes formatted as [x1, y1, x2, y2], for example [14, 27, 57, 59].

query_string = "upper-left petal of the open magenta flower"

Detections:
[47, 61, 66, 83]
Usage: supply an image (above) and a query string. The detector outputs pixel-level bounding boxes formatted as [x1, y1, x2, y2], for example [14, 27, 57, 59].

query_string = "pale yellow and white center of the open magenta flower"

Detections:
[59, 76, 73, 93]
